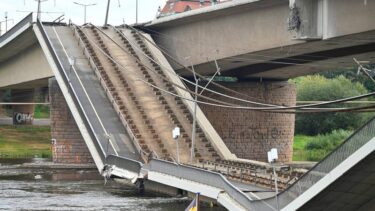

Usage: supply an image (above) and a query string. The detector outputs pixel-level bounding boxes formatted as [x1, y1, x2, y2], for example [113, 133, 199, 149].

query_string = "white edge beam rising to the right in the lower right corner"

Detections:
[282, 138, 375, 211]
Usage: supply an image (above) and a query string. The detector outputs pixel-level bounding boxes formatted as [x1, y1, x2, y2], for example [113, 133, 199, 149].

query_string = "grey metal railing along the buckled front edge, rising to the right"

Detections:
[150, 114, 375, 210]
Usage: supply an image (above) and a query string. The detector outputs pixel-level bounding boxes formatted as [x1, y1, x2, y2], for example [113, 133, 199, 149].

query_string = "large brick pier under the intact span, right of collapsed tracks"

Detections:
[200, 82, 296, 162]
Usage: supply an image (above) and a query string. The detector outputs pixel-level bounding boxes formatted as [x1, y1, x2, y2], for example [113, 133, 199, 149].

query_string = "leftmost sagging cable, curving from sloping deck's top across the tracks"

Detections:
[76, 26, 375, 111]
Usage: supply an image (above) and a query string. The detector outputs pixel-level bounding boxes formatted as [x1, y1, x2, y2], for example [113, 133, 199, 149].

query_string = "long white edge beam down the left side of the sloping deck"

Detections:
[33, 24, 104, 173]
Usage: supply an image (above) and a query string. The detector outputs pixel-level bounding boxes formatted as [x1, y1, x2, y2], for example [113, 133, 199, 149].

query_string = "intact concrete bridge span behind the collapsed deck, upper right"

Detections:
[145, 0, 375, 80]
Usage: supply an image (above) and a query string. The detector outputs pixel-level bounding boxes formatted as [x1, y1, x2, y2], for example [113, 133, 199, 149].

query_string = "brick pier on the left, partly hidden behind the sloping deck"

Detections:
[49, 79, 93, 164]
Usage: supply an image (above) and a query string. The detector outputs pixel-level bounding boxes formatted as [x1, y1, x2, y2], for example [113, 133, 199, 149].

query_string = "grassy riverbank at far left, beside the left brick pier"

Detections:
[0, 126, 51, 158]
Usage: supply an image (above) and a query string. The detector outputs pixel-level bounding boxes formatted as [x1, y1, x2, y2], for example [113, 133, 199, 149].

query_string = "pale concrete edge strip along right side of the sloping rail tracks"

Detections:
[143, 34, 237, 160]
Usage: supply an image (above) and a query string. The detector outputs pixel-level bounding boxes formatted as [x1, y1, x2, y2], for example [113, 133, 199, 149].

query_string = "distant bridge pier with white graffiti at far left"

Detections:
[11, 89, 35, 125]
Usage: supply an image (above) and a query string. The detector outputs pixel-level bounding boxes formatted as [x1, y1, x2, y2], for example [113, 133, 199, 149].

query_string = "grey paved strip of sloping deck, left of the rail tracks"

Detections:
[45, 26, 140, 160]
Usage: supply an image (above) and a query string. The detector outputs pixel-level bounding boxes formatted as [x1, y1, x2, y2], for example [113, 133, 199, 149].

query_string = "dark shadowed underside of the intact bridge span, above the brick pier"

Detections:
[195, 31, 375, 80]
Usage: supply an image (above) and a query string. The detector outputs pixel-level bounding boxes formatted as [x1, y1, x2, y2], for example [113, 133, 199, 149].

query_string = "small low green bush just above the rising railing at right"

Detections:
[305, 130, 352, 161]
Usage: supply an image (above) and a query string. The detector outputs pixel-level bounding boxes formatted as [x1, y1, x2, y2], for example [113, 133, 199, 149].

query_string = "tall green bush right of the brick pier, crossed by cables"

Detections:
[294, 75, 370, 135]
